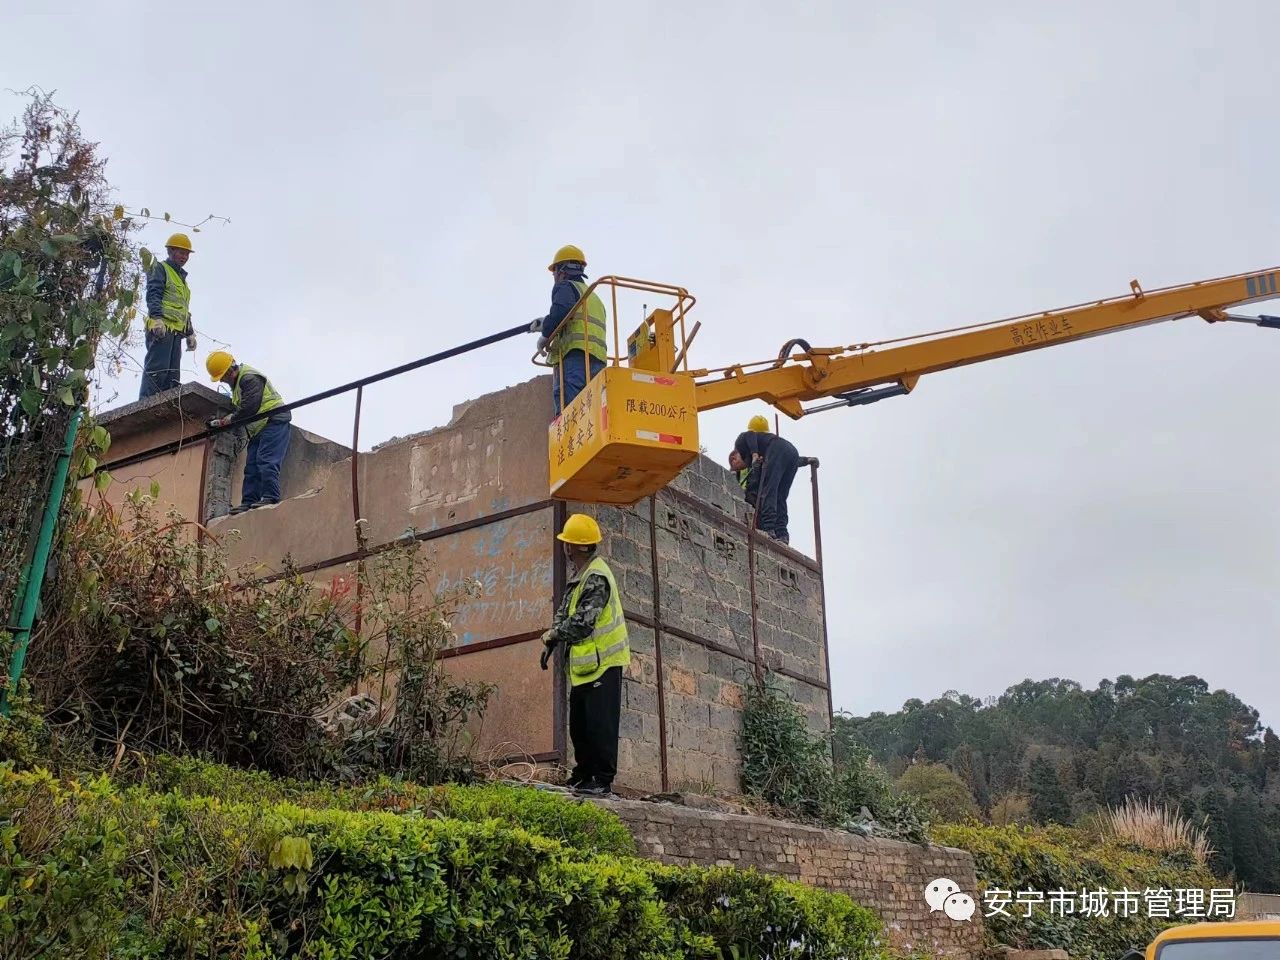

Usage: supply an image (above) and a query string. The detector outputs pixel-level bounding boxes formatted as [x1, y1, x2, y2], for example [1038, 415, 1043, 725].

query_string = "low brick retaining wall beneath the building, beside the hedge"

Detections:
[595, 800, 983, 957]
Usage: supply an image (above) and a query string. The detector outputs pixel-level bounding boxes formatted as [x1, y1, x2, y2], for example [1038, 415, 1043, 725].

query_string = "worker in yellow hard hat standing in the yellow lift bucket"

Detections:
[529, 244, 609, 416]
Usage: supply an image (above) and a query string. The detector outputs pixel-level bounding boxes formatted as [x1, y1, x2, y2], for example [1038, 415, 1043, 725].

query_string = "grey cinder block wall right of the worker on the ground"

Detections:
[570, 457, 831, 792]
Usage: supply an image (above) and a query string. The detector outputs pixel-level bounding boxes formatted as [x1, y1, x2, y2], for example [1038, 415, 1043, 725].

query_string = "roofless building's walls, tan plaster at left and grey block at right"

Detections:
[90, 378, 829, 792]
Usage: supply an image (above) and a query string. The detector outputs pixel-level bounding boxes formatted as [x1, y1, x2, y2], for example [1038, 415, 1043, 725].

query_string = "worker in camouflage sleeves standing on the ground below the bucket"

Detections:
[541, 513, 631, 795]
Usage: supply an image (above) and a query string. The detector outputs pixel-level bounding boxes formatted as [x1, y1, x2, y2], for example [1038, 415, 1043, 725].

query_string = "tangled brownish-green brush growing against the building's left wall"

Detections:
[27, 496, 492, 783]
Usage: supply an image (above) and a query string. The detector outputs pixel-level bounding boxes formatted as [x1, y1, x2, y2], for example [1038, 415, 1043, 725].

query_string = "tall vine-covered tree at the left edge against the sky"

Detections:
[0, 90, 141, 627]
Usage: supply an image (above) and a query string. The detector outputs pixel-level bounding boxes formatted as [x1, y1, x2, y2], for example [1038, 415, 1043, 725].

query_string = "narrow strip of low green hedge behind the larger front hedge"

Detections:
[141, 756, 635, 855]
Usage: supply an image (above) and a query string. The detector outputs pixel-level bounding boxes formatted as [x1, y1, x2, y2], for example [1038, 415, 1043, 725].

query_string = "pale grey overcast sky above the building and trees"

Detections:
[10, 0, 1280, 724]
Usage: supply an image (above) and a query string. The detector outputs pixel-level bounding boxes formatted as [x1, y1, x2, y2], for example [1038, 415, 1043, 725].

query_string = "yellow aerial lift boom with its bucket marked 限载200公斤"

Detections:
[548, 268, 1280, 504]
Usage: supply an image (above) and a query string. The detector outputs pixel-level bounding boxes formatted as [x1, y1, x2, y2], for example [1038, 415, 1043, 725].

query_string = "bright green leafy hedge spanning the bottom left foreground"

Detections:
[0, 769, 881, 960]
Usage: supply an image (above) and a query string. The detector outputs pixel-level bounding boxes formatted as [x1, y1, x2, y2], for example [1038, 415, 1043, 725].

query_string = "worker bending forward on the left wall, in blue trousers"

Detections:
[205, 349, 293, 513]
